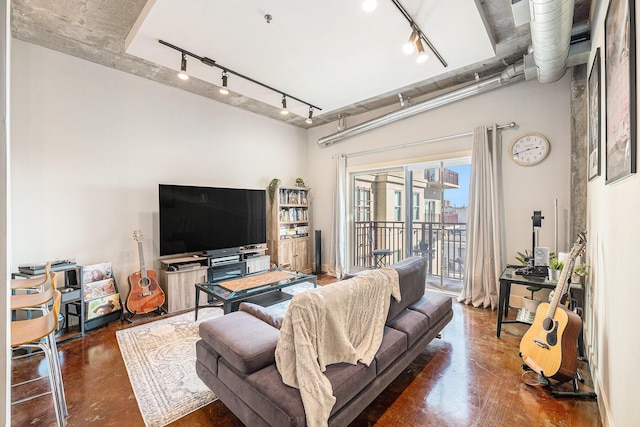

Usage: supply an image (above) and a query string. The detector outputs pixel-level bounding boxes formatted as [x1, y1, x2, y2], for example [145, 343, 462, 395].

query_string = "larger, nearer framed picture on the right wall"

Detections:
[605, 0, 636, 184]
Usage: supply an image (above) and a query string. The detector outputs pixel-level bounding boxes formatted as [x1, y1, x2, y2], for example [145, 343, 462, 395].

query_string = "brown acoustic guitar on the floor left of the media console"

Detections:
[127, 230, 164, 316]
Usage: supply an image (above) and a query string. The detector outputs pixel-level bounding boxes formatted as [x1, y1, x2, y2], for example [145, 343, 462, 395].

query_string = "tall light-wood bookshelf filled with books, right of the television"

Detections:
[267, 186, 313, 273]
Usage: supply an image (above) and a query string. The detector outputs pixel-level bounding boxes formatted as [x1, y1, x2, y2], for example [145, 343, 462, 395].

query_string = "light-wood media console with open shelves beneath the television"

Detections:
[160, 247, 270, 313]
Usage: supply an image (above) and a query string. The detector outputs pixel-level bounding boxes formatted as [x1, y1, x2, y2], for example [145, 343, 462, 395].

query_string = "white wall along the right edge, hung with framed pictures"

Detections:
[585, 1, 640, 426]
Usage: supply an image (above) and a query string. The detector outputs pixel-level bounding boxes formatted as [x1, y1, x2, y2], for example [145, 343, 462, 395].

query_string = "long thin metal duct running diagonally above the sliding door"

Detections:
[318, 61, 524, 146]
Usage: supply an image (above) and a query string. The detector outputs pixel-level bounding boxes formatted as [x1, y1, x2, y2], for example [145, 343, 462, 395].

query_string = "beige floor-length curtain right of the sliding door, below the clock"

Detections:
[458, 125, 502, 309]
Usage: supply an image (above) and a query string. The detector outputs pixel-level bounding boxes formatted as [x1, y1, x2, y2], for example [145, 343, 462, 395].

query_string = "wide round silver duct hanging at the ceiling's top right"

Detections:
[529, 0, 574, 83]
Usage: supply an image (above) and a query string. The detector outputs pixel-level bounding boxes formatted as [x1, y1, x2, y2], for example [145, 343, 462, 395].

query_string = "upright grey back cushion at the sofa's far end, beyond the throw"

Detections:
[387, 257, 427, 320]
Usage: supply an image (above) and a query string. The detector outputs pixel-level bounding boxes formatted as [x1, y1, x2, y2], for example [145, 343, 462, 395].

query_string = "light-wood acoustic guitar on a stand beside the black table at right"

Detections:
[520, 232, 587, 382]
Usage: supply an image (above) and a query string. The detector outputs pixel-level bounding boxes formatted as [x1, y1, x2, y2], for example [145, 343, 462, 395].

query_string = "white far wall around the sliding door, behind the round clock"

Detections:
[308, 73, 571, 288]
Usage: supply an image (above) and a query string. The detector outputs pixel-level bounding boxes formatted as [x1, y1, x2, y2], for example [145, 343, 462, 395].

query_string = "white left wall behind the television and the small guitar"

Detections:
[11, 40, 307, 298]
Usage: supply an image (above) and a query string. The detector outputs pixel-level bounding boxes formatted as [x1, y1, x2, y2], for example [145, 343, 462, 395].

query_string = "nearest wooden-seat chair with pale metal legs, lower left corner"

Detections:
[11, 289, 69, 426]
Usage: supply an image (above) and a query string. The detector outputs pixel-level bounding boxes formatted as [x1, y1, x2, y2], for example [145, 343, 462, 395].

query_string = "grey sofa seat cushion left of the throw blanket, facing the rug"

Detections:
[199, 311, 279, 374]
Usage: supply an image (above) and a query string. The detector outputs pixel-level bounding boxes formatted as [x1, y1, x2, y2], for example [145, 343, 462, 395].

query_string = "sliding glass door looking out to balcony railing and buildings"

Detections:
[350, 158, 471, 293]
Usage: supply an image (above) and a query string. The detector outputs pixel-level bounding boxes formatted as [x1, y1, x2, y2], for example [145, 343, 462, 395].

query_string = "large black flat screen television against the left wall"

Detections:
[158, 184, 267, 256]
